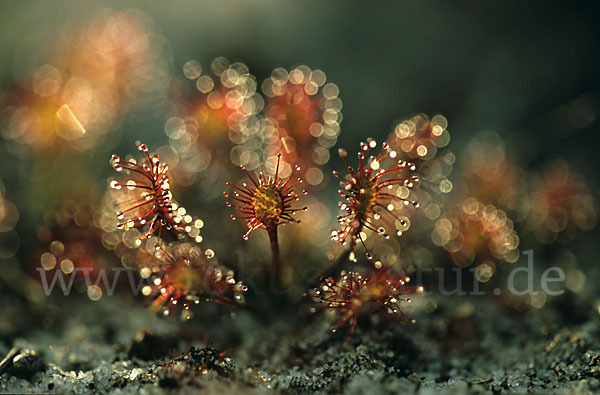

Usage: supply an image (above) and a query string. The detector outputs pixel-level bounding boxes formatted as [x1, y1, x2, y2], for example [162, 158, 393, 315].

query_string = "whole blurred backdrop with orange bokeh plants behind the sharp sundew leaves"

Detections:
[0, 0, 600, 342]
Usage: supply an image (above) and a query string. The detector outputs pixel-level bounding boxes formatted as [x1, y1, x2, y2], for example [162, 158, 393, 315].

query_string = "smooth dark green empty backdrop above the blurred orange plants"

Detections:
[0, 1, 600, 170]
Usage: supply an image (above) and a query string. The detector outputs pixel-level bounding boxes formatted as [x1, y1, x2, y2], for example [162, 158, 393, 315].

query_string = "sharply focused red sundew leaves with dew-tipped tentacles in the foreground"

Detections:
[110, 135, 422, 333]
